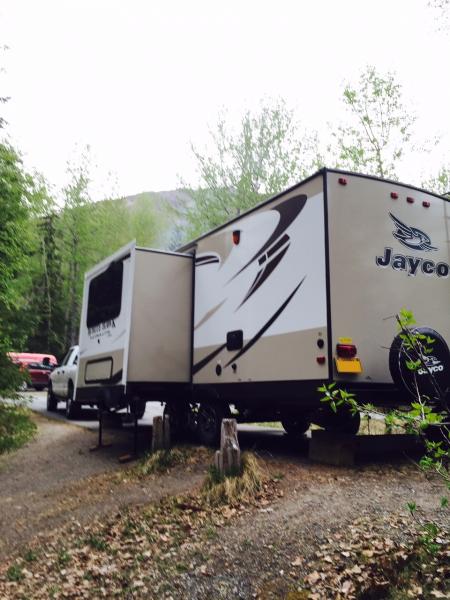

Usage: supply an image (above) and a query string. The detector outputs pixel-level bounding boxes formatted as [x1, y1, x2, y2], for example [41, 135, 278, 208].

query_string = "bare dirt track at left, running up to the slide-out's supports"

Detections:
[0, 414, 206, 558]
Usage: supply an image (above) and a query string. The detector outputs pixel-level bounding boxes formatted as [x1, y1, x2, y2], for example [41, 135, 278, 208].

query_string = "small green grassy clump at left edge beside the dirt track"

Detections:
[0, 402, 37, 454]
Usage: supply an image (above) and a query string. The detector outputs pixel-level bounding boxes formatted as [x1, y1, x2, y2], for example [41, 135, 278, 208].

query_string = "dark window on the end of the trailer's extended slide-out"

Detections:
[87, 261, 123, 327]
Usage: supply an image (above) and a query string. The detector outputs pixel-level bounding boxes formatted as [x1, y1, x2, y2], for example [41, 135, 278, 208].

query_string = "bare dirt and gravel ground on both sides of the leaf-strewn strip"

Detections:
[0, 417, 448, 600]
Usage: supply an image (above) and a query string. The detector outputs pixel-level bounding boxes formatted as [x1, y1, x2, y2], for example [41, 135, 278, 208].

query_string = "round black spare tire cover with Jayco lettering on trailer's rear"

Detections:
[389, 327, 450, 400]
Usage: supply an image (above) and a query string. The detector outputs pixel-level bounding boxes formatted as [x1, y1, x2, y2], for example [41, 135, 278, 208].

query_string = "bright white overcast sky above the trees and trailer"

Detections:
[0, 0, 450, 195]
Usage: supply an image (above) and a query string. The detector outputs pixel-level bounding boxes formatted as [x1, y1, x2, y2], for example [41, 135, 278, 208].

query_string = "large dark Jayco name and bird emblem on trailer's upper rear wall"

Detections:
[375, 213, 450, 277]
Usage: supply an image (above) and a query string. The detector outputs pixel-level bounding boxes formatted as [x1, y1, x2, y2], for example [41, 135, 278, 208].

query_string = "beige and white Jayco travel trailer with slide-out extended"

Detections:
[77, 169, 450, 443]
